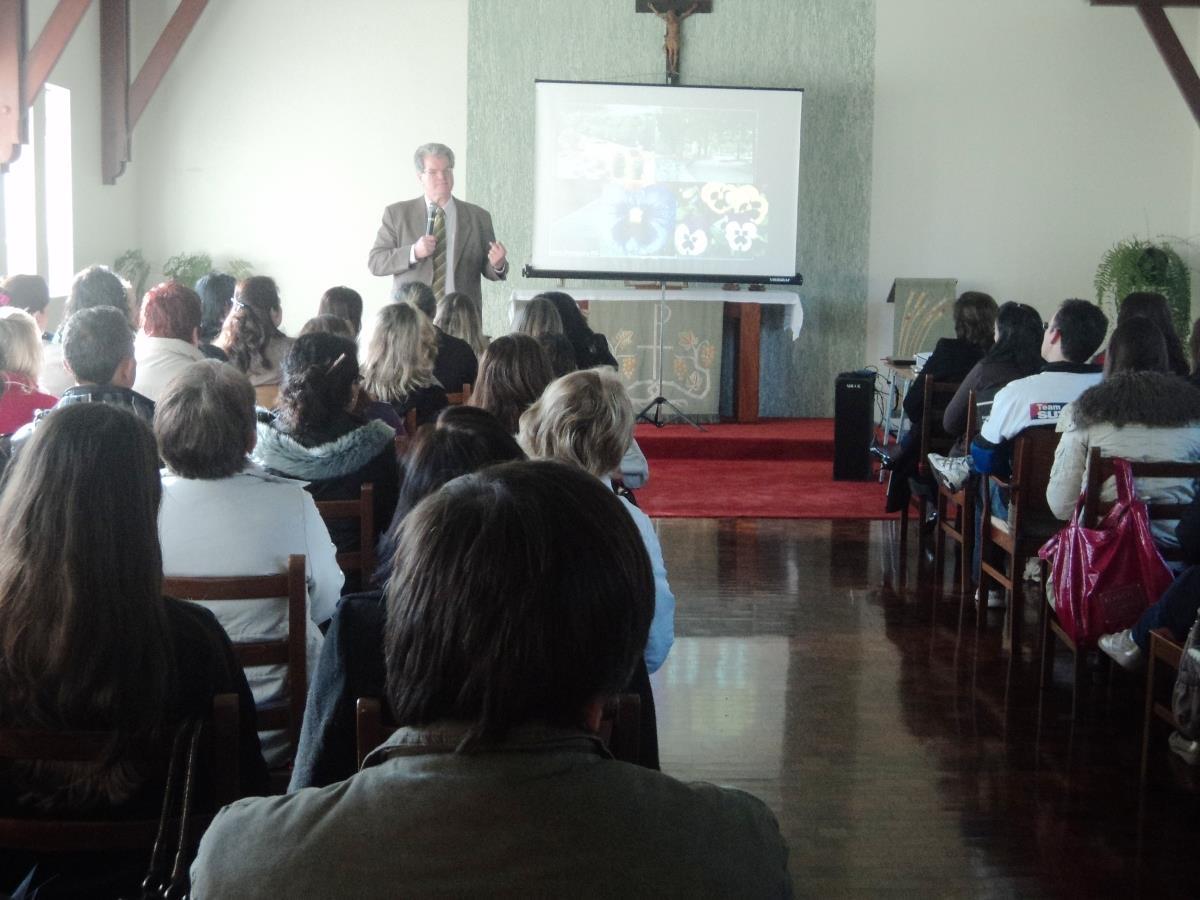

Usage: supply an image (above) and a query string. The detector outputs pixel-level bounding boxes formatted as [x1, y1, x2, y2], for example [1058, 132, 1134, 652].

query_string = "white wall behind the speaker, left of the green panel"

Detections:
[130, 0, 470, 334]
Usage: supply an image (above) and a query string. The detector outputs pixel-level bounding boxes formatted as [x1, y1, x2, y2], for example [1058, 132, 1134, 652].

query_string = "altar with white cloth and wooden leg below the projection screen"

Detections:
[509, 288, 804, 422]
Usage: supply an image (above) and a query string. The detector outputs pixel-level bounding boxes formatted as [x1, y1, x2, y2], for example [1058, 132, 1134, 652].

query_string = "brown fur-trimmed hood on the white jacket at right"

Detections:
[1072, 372, 1200, 428]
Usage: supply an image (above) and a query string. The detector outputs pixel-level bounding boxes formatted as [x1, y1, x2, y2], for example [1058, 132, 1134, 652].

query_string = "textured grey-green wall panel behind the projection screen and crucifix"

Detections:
[467, 0, 875, 415]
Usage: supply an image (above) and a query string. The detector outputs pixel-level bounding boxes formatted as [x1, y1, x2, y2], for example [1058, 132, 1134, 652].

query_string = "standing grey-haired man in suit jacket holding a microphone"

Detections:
[367, 144, 509, 310]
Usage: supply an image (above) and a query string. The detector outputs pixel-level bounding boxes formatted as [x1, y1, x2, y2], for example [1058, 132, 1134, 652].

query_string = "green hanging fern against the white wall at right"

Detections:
[1094, 238, 1192, 340]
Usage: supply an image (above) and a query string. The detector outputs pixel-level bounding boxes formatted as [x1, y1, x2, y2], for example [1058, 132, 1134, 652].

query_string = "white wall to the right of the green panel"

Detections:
[865, 0, 1200, 361]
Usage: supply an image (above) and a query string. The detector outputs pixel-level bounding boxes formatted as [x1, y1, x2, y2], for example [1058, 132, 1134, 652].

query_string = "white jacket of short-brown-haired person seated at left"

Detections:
[158, 462, 343, 766]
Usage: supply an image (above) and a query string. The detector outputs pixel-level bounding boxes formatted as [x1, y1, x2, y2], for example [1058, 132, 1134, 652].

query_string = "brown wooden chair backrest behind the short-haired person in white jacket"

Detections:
[162, 554, 308, 746]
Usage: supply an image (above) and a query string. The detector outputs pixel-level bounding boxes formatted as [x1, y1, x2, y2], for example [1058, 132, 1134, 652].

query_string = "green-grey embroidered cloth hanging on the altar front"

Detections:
[588, 299, 724, 419]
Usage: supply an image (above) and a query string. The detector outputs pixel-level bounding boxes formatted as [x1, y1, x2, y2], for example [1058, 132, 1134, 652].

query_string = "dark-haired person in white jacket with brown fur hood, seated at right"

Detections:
[1046, 318, 1200, 547]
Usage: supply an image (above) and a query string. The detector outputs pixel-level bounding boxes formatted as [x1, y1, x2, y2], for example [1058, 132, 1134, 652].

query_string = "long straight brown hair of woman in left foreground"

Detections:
[0, 403, 175, 805]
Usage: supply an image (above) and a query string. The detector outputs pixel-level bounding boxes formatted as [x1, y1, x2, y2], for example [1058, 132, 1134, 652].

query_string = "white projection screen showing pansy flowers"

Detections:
[527, 80, 804, 283]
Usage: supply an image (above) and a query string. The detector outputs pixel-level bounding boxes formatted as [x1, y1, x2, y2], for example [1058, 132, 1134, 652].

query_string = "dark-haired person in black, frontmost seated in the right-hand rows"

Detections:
[887, 290, 996, 512]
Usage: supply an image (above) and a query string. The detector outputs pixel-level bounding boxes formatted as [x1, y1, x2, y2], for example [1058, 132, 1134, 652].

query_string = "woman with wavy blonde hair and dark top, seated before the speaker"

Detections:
[362, 301, 448, 425]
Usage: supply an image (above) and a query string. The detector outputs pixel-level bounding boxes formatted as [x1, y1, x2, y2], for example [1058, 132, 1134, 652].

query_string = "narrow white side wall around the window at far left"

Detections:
[26, 0, 138, 319]
